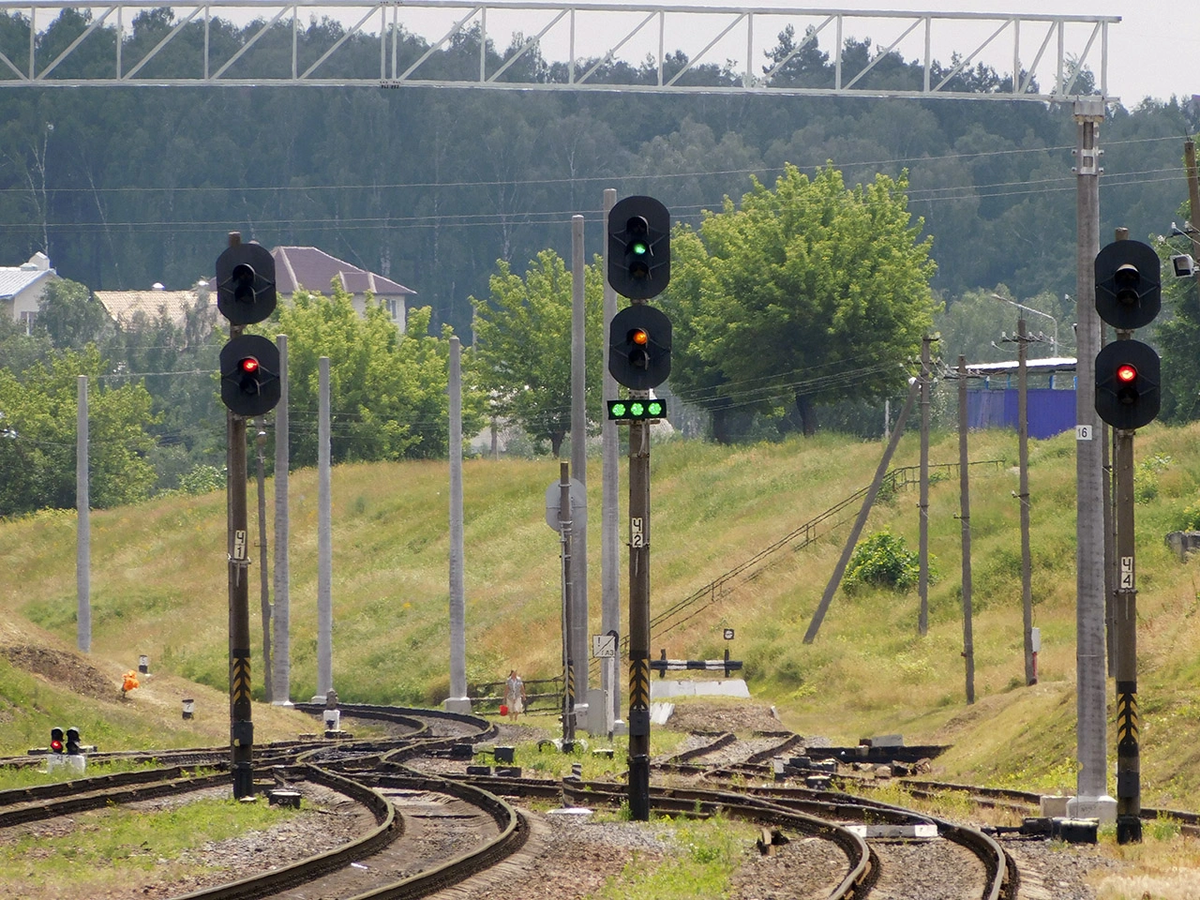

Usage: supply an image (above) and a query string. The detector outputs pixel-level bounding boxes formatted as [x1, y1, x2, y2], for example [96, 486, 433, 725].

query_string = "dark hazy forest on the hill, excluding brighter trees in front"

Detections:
[0, 10, 1200, 338]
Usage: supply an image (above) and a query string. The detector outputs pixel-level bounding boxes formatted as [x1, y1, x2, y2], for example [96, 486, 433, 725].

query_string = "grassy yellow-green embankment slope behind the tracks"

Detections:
[0, 426, 1200, 806]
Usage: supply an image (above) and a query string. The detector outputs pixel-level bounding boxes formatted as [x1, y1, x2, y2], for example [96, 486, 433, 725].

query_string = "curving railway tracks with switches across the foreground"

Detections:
[0, 704, 1200, 900]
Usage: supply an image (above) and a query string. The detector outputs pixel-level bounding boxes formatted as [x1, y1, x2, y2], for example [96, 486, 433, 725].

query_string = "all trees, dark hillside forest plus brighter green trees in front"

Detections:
[0, 10, 1200, 515]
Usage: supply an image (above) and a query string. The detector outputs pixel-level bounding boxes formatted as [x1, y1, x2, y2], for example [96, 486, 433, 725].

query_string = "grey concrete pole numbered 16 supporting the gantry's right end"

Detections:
[1073, 100, 1112, 815]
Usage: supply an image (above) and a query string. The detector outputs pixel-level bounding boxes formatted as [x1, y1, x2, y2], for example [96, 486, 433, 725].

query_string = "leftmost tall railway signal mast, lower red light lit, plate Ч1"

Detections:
[216, 232, 281, 800]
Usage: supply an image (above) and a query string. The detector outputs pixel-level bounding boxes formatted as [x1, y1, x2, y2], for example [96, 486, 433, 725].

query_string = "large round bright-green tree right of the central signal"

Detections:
[665, 164, 935, 439]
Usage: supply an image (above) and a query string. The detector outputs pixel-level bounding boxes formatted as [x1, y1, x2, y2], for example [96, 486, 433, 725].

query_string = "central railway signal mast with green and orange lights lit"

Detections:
[607, 197, 671, 822]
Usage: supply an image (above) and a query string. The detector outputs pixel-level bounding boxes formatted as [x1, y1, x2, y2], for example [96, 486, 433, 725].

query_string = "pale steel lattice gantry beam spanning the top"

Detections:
[0, 0, 1120, 102]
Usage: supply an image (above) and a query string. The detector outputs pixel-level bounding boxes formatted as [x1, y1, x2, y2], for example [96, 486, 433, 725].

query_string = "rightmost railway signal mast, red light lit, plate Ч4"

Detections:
[1096, 240, 1162, 844]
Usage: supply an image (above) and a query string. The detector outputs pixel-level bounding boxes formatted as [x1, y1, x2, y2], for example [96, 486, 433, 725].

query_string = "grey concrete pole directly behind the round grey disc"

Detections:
[571, 216, 589, 702]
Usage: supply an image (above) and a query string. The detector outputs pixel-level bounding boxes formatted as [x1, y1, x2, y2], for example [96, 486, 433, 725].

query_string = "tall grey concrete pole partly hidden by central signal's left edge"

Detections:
[600, 187, 623, 730]
